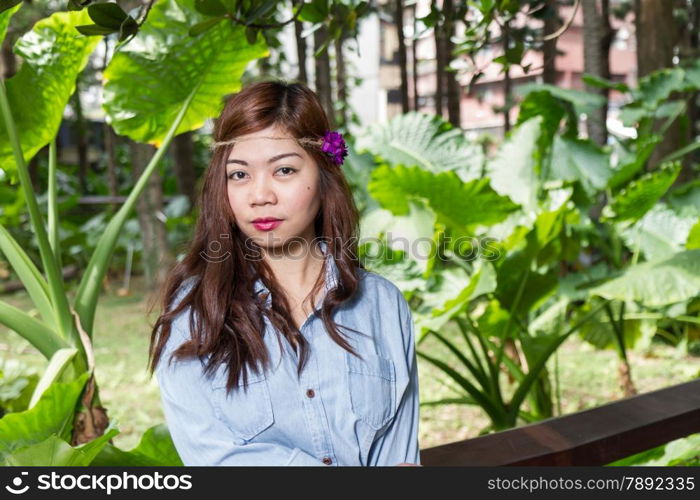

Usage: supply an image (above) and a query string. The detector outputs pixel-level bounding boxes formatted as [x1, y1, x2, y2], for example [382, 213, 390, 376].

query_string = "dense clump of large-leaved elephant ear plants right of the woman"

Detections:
[356, 61, 700, 433]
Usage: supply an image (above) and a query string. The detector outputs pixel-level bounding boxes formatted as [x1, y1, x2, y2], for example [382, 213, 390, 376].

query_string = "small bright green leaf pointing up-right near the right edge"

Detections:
[603, 162, 681, 221]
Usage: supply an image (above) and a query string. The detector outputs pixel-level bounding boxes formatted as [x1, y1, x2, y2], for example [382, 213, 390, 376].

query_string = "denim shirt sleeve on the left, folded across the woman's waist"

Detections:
[156, 292, 325, 467]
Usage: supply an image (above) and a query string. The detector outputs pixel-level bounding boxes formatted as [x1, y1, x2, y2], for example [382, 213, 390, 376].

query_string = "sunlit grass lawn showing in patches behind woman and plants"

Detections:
[0, 279, 700, 449]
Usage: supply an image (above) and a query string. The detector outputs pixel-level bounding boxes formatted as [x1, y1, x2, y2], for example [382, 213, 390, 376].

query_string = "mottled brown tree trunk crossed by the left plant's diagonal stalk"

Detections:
[129, 140, 172, 290]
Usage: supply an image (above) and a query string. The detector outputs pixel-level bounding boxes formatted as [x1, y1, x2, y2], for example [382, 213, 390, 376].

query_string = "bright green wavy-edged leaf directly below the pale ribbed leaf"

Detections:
[369, 165, 517, 229]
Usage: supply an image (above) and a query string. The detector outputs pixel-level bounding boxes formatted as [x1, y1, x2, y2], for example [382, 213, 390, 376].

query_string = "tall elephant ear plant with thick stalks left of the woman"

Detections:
[0, 0, 269, 465]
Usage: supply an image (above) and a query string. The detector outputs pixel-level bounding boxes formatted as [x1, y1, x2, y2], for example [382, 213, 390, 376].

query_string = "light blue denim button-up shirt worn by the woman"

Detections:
[156, 243, 420, 466]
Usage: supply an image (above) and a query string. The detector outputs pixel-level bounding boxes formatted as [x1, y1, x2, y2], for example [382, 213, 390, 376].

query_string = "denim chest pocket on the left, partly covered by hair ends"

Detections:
[212, 370, 275, 442]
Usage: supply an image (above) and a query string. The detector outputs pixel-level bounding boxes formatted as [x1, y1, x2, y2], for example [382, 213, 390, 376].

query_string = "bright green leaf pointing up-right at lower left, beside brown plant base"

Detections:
[0, 372, 89, 460]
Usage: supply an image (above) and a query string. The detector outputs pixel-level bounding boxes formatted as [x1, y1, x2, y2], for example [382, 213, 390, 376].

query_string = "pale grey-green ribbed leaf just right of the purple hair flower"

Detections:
[355, 112, 484, 180]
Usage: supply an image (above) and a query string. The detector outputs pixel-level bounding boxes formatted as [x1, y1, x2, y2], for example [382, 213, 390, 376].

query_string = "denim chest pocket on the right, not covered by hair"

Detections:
[345, 351, 396, 430]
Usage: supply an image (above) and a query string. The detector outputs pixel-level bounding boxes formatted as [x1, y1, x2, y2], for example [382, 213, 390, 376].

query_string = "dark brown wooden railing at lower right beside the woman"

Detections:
[421, 379, 700, 466]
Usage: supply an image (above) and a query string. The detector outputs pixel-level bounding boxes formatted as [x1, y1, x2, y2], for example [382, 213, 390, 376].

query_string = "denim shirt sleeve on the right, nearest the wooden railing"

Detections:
[367, 301, 420, 466]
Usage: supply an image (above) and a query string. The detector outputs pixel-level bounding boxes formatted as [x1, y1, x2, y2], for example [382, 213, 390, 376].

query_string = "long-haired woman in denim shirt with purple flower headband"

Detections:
[149, 81, 420, 466]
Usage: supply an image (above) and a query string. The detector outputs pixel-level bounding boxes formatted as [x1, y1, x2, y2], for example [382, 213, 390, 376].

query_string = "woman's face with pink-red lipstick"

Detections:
[226, 127, 321, 248]
